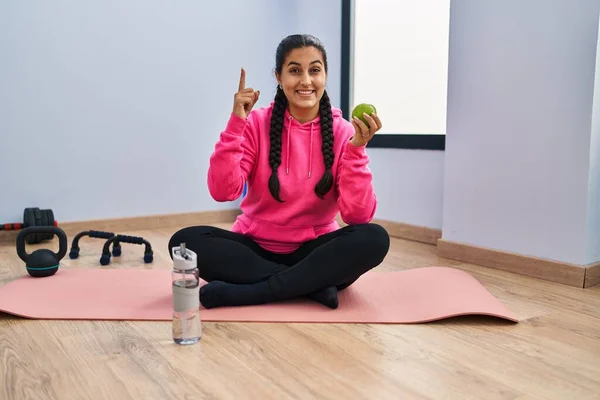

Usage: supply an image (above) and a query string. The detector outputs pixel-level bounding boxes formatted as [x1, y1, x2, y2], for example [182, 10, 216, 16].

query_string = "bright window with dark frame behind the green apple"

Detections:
[342, 0, 450, 150]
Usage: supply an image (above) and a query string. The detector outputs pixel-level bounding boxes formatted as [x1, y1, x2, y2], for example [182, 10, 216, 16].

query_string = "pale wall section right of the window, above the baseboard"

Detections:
[443, 0, 600, 264]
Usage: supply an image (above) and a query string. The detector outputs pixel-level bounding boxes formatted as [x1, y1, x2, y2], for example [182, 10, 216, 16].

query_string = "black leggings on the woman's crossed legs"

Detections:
[169, 224, 390, 300]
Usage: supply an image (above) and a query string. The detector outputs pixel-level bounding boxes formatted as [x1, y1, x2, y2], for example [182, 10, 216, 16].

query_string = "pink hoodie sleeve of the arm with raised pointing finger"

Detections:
[208, 112, 257, 202]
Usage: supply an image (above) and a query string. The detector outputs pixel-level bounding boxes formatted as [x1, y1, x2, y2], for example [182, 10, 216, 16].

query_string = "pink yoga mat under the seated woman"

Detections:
[0, 267, 518, 324]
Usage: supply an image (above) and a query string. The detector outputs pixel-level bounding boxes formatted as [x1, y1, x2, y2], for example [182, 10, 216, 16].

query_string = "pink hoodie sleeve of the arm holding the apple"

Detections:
[337, 141, 377, 225]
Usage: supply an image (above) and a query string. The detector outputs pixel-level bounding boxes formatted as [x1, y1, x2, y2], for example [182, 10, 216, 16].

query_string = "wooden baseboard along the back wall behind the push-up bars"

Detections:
[0, 209, 240, 243]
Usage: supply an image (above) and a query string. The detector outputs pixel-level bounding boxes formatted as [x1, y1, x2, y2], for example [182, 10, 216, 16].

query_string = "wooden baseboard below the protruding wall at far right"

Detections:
[437, 239, 600, 288]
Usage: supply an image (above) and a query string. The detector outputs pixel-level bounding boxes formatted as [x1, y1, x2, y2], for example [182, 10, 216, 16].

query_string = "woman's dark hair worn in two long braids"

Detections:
[269, 35, 334, 203]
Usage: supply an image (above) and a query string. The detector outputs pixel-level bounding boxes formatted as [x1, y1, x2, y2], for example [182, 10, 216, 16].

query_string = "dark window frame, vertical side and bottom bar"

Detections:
[340, 0, 446, 150]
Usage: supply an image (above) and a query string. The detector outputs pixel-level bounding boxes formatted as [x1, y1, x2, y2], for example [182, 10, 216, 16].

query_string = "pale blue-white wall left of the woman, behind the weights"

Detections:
[0, 0, 292, 223]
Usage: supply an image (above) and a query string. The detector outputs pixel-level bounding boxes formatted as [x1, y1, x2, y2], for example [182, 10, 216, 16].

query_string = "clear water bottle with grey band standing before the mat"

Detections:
[171, 243, 202, 345]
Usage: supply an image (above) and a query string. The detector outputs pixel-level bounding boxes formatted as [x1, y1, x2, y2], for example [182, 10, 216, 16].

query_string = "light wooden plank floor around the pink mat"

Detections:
[0, 225, 600, 400]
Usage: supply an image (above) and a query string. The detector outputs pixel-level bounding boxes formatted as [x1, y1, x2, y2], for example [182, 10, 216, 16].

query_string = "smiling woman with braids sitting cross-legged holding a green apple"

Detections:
[169, 35, 390, 308]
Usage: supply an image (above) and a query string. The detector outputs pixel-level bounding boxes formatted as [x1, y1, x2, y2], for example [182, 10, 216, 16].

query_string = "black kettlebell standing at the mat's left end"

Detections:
[17, 226, 67, 278]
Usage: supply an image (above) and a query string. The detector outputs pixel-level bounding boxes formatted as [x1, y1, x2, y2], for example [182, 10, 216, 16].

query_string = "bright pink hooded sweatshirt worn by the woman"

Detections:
[208, 103, 377, 253]
